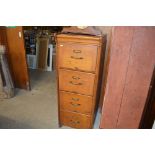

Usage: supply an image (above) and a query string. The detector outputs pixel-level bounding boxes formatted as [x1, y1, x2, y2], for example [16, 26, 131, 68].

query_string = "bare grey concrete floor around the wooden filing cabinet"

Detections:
[0, 70, 100, 129]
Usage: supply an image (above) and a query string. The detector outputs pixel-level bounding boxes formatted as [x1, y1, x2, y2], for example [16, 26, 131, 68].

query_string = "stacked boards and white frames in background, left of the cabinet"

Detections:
[24, 29, 53, 71]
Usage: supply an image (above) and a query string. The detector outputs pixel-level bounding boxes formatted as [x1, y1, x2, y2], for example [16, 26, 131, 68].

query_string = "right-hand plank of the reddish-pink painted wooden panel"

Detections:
[117, 27, 155, 128]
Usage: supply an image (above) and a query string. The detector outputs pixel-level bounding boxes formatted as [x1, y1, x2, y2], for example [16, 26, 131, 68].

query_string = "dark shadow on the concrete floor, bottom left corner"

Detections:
[0, 116, 32, 129]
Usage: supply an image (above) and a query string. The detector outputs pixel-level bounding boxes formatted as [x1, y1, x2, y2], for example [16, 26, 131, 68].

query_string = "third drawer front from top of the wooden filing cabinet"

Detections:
[60, 91, 92, 114]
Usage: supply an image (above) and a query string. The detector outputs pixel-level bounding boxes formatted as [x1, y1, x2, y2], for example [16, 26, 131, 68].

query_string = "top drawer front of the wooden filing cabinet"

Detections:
[58, 43, 97, 72]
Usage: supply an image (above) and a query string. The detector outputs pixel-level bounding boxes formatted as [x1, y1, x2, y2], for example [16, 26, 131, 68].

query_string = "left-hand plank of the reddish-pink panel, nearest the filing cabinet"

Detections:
[100, 27, 134, 128]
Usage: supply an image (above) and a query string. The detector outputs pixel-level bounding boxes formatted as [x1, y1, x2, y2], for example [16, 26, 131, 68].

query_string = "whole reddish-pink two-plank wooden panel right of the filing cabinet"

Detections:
[100, 27, 155, 128]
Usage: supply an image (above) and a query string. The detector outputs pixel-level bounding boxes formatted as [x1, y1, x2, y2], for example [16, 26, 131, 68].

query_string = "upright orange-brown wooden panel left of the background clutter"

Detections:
[6, 26, 29, 89]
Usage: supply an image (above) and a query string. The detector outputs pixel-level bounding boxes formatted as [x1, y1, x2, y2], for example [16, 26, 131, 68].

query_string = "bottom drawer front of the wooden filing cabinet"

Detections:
[60, 111, 91, 129]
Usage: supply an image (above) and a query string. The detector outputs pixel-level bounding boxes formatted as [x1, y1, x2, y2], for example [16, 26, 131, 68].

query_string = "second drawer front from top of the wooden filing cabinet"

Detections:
[59, 69, 95, 95]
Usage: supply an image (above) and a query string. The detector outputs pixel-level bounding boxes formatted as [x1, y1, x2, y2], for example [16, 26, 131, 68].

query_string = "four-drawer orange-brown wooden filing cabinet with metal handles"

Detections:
[56, 34, 105, 128]
